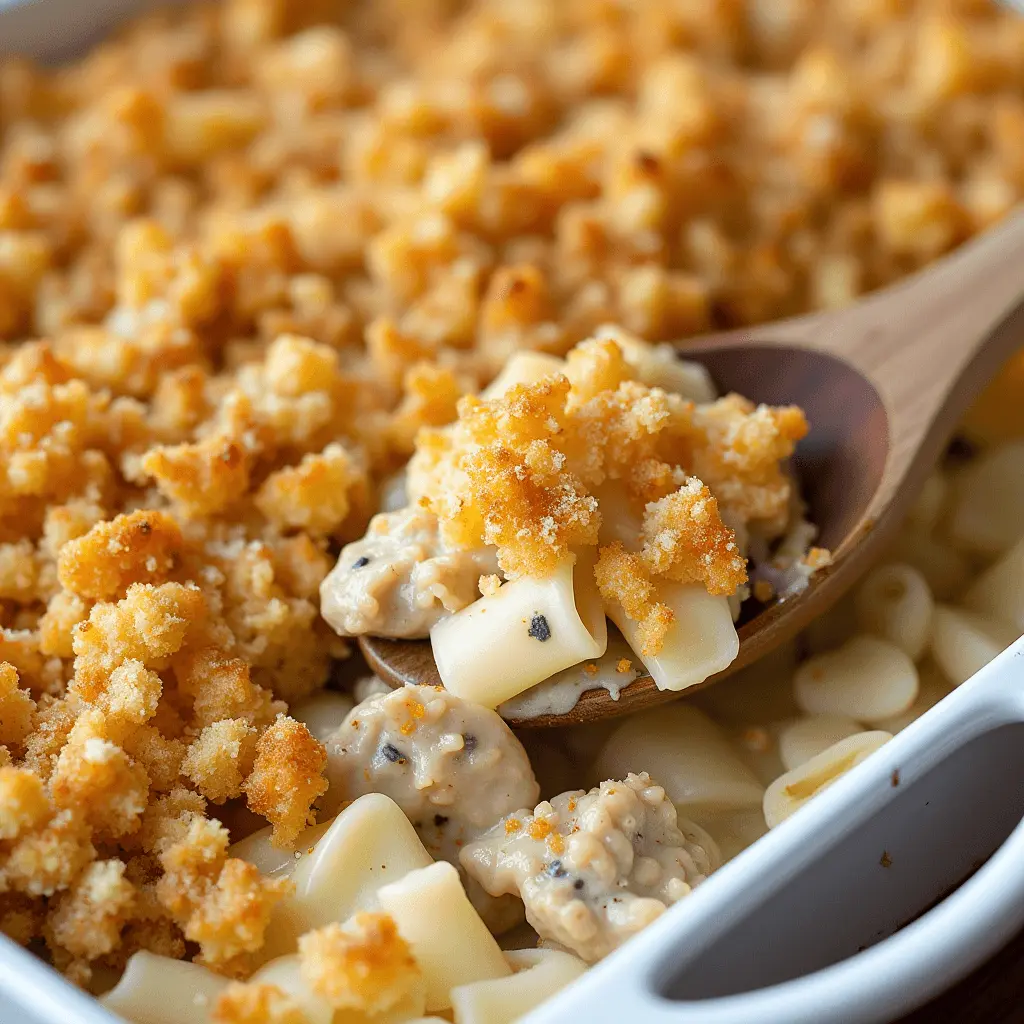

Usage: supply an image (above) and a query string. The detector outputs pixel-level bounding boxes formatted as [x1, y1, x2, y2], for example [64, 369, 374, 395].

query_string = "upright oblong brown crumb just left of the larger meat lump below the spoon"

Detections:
[243, 715, 327, 847]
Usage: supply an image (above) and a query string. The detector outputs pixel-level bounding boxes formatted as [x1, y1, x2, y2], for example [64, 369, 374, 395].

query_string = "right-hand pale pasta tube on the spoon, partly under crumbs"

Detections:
[605, 580, 739, 690]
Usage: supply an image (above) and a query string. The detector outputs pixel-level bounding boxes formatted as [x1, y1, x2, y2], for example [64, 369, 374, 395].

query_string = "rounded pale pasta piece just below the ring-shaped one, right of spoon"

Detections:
[794, 635, 918, 722]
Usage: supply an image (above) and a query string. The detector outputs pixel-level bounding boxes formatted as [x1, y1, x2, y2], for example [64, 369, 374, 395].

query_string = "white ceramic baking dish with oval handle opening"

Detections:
[0, 0, 1024, 1024]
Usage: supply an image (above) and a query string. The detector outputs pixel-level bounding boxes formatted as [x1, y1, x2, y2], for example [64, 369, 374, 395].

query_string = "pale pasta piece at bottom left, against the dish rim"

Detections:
[99, 950, 229, 1024]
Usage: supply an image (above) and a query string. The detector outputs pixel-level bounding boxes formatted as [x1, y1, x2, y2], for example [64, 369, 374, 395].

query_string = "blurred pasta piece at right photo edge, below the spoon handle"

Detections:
[947, 440, 1024, 555]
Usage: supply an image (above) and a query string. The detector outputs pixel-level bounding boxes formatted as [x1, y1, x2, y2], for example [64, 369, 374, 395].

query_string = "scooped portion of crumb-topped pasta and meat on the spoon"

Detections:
[321, 328, 827, 708]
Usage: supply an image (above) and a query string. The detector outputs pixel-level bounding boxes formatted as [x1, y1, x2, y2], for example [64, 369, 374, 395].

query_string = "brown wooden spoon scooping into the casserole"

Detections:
[359, 211, 1024, 726]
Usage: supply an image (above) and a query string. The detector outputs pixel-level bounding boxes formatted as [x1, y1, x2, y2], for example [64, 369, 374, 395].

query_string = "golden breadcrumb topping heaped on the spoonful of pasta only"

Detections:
[410, 331, 807, 638]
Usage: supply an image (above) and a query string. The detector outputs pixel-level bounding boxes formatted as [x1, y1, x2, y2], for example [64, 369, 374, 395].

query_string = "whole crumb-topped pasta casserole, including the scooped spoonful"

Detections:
[0, 0, 1024, 1024]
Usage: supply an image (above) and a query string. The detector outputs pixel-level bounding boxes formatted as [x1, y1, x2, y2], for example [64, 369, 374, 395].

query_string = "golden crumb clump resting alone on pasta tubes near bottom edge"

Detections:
[299, 913, 421, 1016]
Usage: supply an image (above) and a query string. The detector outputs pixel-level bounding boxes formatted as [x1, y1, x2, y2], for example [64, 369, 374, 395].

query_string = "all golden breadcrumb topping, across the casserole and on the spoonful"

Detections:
[0, 0, 1024, 995]
